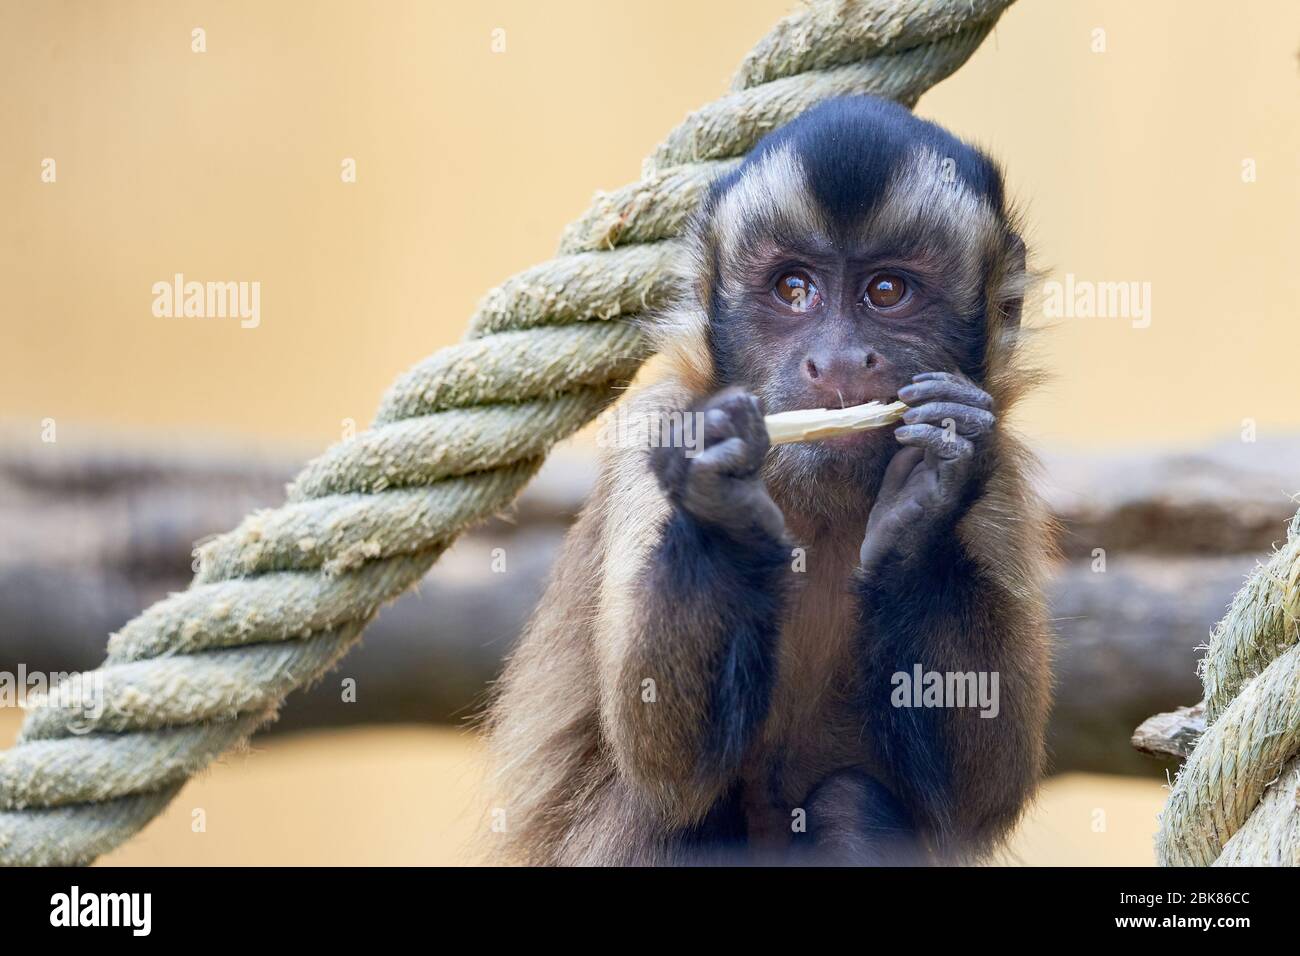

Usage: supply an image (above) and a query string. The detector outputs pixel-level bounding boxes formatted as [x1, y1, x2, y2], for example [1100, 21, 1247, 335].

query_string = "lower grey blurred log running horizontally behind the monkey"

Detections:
[0, 538, 1251, 774]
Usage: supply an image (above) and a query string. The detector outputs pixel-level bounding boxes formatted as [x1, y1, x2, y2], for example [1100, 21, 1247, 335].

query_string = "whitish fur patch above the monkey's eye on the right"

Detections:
[863, 147, 1002, 306]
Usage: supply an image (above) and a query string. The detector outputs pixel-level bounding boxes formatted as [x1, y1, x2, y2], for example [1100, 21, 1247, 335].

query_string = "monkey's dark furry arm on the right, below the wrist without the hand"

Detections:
[861, 512, 1048, 855]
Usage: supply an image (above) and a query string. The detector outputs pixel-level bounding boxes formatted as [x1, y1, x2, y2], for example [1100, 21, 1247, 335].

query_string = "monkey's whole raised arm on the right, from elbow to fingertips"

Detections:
[859, 376, 1049, 855]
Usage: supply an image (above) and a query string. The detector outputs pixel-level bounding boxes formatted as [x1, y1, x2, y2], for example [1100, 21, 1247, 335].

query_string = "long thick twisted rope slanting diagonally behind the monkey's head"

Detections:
[0, 0, 1011, 865]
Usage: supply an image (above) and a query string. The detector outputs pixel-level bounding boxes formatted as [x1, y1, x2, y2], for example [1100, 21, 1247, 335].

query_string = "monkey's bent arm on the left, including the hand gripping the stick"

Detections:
[599, 393, 790, 826]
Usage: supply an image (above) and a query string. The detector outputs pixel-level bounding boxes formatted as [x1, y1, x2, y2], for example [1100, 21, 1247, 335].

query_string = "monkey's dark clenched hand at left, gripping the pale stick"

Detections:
[650, 388, 785, 541]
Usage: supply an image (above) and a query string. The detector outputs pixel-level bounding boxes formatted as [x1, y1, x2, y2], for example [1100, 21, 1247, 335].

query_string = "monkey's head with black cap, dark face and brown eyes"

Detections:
[697, 98, 1022, 504]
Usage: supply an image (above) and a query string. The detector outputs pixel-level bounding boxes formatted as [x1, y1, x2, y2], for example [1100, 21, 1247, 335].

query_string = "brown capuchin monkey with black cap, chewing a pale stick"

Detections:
[488, 96, 1050, 865]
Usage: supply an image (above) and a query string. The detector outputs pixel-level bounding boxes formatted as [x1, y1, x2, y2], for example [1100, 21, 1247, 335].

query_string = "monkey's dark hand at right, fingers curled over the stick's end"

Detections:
[861, 372, 997, 574]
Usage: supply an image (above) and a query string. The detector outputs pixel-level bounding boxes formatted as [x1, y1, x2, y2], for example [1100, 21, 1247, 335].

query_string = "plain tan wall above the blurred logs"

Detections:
[0, 0, 1300, 445]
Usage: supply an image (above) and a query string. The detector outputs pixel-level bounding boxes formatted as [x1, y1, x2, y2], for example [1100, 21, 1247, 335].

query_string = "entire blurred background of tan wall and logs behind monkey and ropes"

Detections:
[0, 0, 1300, 865]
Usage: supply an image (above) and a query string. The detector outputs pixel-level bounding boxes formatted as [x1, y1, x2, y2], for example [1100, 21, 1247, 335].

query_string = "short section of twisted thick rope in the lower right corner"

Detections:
[1156, 514, 1300, 866]
